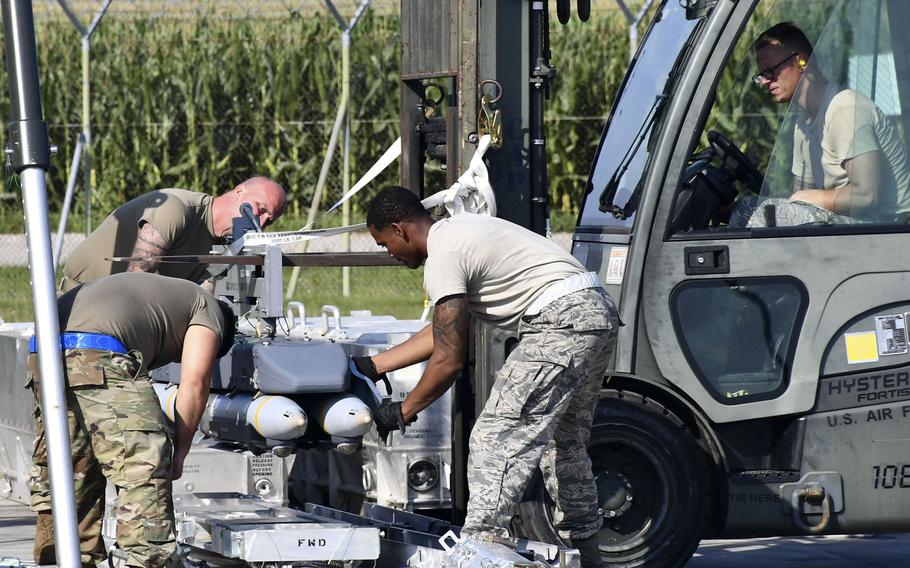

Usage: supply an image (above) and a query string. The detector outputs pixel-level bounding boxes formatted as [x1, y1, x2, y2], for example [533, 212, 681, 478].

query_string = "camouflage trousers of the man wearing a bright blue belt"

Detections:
[29, 349, 175, 566]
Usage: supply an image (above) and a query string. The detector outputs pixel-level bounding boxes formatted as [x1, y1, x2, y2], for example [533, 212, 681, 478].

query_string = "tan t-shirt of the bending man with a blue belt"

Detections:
[57, 272, 224, 370]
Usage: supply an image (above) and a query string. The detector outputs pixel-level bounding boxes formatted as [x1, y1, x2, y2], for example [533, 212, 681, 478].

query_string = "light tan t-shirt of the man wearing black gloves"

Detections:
[423, 213, 585, 330]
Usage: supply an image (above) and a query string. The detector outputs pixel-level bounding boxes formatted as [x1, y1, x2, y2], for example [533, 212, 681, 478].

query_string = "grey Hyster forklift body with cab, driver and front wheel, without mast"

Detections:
[573, 0, 910, 566]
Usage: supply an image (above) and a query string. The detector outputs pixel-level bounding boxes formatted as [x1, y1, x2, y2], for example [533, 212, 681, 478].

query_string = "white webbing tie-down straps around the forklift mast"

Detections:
[239, 134, 496, 254]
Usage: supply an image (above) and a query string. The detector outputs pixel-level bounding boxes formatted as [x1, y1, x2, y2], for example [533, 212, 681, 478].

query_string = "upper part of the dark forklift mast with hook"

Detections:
[400, 0, 547, 233]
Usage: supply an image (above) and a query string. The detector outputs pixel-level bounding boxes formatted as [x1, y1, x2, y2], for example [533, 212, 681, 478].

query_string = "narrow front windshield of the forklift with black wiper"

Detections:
[579, 0, 702, 233]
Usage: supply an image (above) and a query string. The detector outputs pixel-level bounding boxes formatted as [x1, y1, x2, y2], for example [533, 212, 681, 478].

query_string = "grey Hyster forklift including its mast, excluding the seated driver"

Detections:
[401, 0, 910, 567]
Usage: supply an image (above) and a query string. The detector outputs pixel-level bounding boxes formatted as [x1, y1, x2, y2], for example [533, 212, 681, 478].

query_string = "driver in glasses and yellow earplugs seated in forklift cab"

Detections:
[730, 22, 910, 227]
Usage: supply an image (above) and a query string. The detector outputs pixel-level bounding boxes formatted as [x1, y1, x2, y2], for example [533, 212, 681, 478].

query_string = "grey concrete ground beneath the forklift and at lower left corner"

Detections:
[0, 499, 910, 568]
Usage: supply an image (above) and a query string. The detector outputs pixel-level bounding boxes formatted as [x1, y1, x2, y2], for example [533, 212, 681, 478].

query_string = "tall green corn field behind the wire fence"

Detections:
[0, 0, 640, 227]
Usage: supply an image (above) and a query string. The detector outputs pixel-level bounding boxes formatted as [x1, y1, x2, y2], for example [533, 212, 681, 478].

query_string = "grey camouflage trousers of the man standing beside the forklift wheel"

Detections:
[463, 289, 618, 539]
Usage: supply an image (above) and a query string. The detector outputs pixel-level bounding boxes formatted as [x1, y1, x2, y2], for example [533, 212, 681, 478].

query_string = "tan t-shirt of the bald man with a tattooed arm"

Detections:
[61, 189, 216, 292]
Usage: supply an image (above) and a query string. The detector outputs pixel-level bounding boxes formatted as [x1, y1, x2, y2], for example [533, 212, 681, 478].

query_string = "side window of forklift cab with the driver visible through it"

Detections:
[668, 0, 910, 236]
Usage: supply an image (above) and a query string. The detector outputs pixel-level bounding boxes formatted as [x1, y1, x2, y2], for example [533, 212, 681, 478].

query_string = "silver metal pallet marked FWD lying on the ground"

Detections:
[161, 495, 579, 568]
